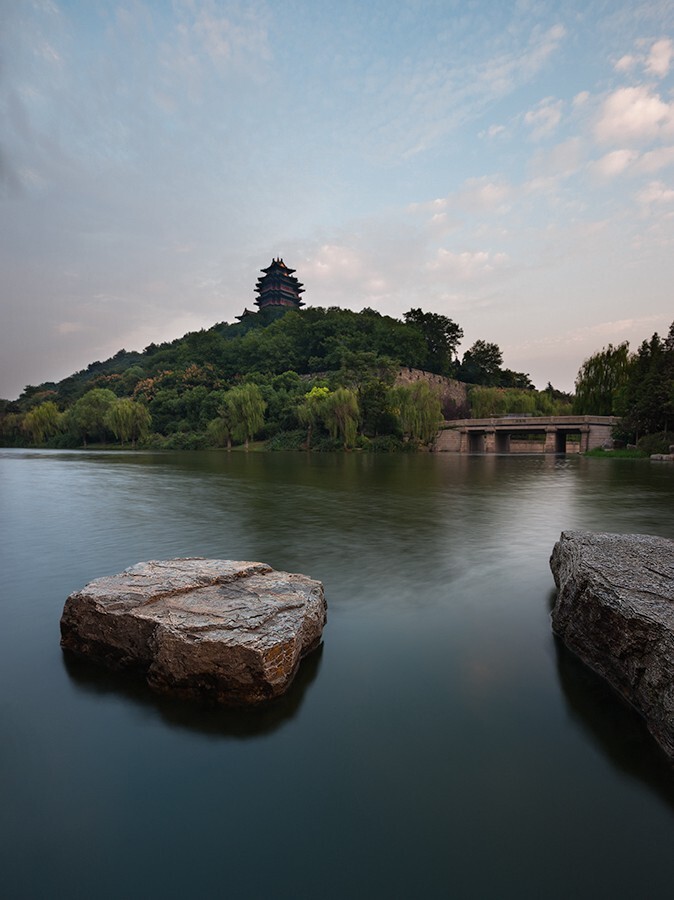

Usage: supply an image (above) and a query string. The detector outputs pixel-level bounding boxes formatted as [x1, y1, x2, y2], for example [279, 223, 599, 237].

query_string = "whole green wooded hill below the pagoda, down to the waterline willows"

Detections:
[0, 308, 571, 450]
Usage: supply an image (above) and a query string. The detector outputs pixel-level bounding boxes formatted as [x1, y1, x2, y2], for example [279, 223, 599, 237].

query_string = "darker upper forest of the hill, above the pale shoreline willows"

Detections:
[6, 307, 532, 410]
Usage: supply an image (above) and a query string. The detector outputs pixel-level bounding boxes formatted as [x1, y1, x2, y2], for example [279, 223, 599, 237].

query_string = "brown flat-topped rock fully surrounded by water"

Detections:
[61, 559, 326, 705]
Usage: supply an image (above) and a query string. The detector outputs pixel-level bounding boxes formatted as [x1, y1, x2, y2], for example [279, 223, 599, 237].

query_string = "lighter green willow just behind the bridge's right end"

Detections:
[573, 341, 631, 416]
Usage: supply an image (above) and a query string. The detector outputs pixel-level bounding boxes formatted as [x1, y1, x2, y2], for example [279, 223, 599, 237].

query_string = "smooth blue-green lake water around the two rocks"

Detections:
[0, 451, 674, 900]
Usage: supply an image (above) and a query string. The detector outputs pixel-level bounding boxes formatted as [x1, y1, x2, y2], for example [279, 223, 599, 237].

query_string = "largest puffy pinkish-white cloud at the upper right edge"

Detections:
[594, 85, 674, 144]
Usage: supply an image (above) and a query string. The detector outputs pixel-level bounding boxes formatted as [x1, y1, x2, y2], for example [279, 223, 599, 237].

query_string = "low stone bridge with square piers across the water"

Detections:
[434, 416, 618, 453]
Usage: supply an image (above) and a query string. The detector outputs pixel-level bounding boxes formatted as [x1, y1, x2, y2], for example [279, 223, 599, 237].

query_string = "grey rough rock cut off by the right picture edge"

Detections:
[550, 531, 674, 757]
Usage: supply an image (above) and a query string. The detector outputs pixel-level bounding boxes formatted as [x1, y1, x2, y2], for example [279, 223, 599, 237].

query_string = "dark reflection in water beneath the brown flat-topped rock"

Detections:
[63, 643, 323, 740]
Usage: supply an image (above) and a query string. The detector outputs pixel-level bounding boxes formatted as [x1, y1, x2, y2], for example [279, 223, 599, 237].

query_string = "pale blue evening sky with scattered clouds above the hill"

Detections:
[0, 0, 674, 399]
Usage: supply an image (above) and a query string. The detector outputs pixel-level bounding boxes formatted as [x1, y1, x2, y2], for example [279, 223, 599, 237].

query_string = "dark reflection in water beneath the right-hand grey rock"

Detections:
[554, 638, 674, 809]
